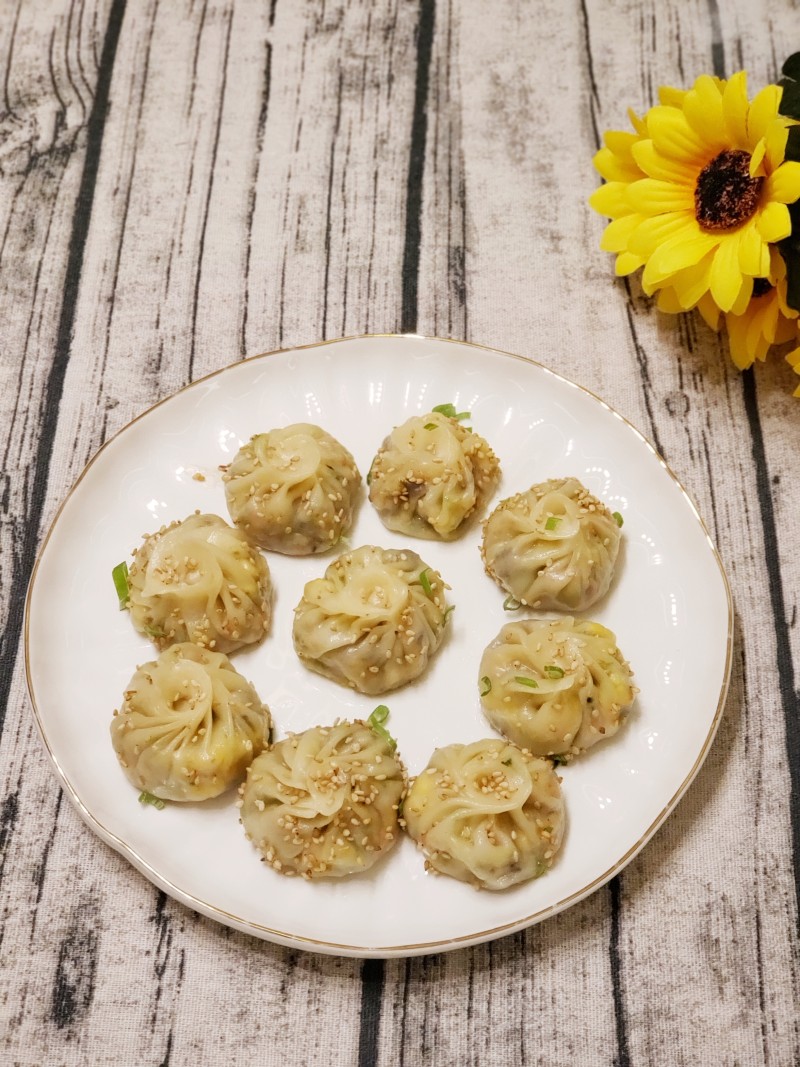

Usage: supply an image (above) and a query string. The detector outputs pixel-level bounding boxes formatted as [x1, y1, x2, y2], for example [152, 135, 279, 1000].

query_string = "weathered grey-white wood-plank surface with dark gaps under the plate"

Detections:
[0, 0, 800, 1067]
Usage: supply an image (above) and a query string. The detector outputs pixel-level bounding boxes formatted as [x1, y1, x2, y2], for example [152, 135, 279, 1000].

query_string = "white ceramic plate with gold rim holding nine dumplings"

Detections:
[26, 336, 733, 956]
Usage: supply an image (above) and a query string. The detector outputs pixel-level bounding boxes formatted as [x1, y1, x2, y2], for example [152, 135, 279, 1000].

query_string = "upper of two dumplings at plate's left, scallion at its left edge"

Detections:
[128, 514, 272, 652]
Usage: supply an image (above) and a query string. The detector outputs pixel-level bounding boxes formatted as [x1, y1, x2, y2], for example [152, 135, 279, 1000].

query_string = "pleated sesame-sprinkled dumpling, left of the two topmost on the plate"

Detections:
[224, 423, 362, 556]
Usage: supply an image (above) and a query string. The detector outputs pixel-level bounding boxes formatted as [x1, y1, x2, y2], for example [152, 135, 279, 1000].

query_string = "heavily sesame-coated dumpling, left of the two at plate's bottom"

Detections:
[239, 721, 405, 878]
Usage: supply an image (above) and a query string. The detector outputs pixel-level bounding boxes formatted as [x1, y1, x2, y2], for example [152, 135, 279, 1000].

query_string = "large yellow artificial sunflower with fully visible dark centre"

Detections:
[590, 71, 800, 316]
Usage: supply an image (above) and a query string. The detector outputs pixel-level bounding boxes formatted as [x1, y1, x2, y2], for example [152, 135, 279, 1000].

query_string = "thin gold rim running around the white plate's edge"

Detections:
[23, 333, 734, 958]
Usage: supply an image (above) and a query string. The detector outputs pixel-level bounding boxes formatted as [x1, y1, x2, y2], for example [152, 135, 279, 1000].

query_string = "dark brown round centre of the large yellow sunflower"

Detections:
[694, 148, 764, 234]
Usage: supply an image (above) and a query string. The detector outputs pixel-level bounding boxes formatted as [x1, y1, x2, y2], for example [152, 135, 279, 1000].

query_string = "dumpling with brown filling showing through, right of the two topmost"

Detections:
[368, 411, 500, 541]
